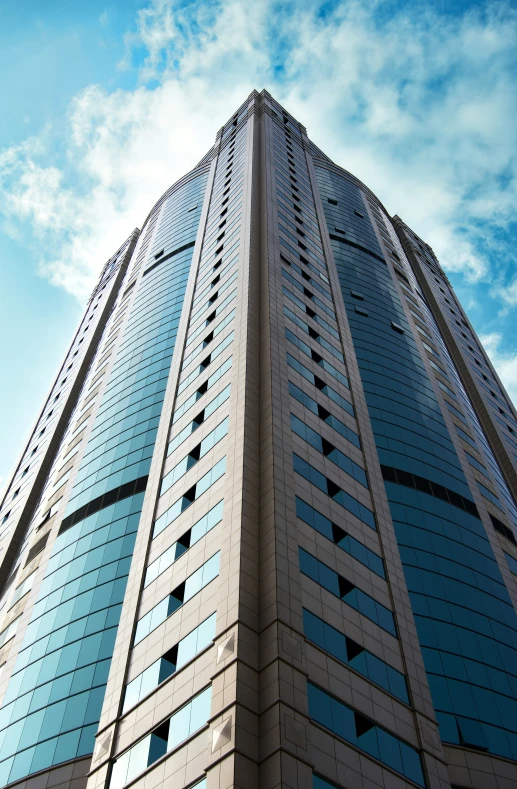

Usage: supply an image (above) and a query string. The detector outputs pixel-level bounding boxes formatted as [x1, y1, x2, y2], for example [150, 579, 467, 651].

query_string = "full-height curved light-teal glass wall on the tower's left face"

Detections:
[0, 169, 208, 785]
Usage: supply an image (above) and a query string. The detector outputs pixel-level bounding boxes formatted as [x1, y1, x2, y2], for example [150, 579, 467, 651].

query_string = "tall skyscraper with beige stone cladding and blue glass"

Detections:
[0, 91, 517, 789]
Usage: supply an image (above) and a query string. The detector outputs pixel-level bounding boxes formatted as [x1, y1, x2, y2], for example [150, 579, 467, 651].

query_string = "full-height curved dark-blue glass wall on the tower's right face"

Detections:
[316, 166, 517, 759]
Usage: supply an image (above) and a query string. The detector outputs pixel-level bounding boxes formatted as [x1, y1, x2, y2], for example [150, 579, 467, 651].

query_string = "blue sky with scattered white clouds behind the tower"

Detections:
[0, 0, 517, 487]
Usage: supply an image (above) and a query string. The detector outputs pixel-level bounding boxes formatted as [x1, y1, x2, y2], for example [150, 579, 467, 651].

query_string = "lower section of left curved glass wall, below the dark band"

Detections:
[0, 494, 143, 783]
